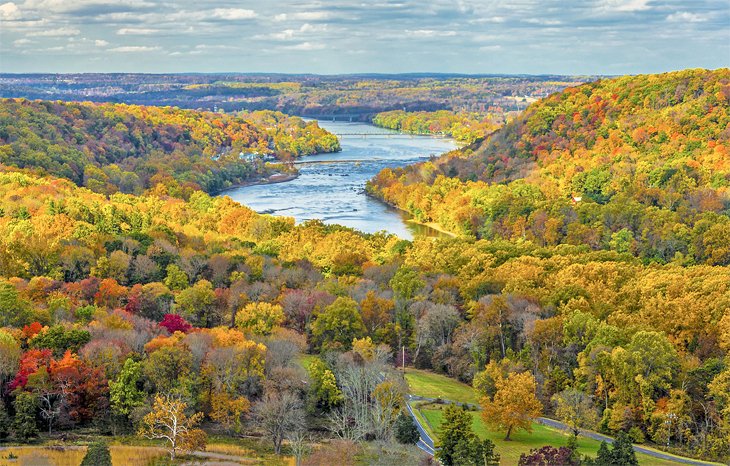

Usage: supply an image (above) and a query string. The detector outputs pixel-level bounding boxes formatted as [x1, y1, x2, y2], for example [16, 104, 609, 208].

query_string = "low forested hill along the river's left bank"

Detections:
[0, 99, 339, 195]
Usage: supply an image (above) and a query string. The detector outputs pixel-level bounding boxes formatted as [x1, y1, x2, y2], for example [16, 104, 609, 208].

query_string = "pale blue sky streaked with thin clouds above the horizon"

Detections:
[0, 0, 730, 75]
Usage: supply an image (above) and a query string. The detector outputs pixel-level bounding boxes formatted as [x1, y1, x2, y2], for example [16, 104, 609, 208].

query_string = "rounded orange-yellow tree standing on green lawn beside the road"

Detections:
[481, 372, 542, 440]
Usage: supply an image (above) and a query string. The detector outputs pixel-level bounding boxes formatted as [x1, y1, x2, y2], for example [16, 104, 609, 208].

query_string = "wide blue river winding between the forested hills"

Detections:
[221, 121, 457, 239]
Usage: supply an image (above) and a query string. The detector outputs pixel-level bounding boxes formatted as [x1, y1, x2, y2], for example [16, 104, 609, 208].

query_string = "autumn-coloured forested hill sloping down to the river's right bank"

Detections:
[369, 69, 730, 265]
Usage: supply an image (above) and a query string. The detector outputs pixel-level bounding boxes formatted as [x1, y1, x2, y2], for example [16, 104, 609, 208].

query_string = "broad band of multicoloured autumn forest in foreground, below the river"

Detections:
[0, 167, 730, 457]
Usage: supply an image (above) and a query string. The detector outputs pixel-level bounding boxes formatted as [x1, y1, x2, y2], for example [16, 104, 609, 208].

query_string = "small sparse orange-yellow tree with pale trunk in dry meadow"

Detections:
[138, 395, 207, 460]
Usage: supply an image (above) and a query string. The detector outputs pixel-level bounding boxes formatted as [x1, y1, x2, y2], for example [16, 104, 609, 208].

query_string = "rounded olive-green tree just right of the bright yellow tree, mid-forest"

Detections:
[312, 296, 365, 350]
